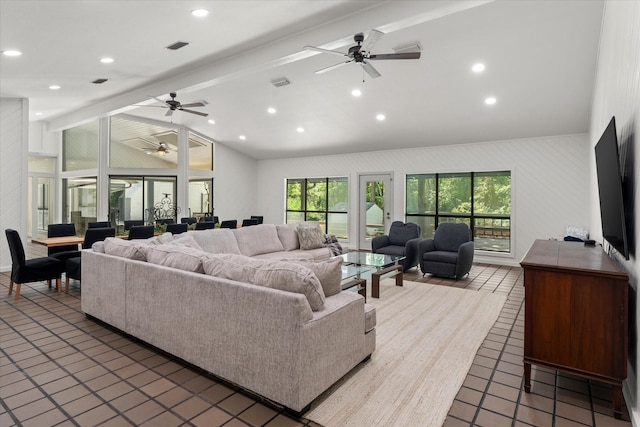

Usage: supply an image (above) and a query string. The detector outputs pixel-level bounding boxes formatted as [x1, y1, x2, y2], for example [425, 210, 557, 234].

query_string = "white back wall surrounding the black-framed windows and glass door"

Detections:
[257, 134, 590, 265]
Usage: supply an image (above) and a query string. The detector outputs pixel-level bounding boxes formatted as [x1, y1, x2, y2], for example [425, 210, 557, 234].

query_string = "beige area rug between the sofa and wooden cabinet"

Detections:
[305, 279, 506, 427]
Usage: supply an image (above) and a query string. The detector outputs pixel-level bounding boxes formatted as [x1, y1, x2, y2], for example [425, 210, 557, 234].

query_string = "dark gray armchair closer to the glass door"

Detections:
[371, 221, 422, 271]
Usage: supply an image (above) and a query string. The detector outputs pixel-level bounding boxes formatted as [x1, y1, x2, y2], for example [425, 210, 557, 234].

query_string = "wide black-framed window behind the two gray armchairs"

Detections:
[406, 171, 511, 252]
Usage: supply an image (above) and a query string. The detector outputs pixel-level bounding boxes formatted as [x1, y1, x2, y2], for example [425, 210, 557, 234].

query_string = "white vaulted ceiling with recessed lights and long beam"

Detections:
[0, 0, 603, 159]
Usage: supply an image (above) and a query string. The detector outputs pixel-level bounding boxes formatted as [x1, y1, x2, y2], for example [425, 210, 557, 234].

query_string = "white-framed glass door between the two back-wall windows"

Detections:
[358, 173, 393, 250]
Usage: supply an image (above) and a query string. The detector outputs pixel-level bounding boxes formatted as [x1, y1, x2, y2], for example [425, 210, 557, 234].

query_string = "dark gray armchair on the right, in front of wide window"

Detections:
[418, 222, 474, 280]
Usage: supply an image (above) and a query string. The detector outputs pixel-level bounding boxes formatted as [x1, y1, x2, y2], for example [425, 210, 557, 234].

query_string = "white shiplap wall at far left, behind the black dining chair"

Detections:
[0, 98, 29, 271]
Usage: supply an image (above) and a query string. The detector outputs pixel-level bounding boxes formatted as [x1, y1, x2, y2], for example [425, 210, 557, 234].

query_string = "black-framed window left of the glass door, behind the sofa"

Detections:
[286, 178, 349, 239]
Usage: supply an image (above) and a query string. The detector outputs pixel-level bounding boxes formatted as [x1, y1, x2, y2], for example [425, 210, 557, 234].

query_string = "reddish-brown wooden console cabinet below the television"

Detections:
[520, 240, 629, 418]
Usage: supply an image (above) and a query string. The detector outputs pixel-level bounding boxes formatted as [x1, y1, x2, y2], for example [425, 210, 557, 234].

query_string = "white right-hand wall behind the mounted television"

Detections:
[589, 1, 640, 426]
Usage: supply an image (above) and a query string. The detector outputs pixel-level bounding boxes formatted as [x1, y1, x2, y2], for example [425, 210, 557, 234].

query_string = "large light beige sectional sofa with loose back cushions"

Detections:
[81, 224, 375, 413]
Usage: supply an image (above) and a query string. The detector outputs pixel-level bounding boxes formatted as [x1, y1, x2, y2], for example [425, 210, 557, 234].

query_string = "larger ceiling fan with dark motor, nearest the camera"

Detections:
[304, 30, 420, 79]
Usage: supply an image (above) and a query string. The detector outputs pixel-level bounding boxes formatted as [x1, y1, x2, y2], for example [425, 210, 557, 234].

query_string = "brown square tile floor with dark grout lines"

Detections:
[0, 245, 631, 427]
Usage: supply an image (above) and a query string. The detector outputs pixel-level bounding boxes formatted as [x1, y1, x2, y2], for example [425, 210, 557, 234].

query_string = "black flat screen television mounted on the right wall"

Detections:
[596, 117, 629, 259]
